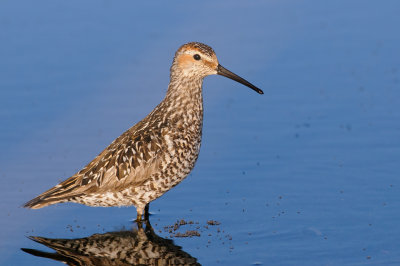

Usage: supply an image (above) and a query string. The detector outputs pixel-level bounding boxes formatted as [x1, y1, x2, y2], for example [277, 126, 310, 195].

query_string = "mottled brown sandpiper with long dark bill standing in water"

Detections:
[24, 42, 263, 221]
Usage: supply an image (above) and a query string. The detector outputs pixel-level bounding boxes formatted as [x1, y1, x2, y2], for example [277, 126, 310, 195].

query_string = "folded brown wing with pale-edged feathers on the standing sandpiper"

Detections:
[38, 125, 162, 202]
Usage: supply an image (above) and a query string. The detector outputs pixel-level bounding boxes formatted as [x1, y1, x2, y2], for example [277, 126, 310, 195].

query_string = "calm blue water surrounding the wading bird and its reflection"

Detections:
[0, 0, 400, 265]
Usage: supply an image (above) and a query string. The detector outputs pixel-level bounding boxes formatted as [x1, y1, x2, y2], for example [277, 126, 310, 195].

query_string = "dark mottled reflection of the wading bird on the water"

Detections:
[22, 222, 200, 266]
